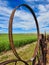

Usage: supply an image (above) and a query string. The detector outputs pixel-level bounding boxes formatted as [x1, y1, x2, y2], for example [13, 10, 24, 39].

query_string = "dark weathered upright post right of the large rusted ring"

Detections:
[40, 34, 47, 65]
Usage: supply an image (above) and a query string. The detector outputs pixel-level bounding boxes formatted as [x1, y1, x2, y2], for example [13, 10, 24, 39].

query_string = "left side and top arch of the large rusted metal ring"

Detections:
[9, 4, 39, 60]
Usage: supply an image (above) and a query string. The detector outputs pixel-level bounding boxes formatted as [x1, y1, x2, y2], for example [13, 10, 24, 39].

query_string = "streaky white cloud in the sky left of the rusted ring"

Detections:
[0, 0, 11, 33]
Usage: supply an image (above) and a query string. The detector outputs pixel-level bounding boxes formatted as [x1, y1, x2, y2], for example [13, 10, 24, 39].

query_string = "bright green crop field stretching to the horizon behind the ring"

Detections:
[0, 34, 37, 52]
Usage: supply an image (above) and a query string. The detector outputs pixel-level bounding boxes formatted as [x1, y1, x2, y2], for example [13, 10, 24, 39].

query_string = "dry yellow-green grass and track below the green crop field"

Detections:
[0, 43, 36, 65]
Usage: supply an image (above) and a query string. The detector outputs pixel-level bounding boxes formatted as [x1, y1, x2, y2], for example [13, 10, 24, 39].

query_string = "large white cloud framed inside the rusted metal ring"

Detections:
[13, 10, 35, 30]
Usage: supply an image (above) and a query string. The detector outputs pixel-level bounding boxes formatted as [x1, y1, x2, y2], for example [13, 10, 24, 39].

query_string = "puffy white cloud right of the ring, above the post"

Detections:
[38, 5, 49, 32]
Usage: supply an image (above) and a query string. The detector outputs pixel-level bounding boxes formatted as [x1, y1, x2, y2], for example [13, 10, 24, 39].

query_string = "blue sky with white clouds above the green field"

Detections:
[0, 0, 49, 33]
